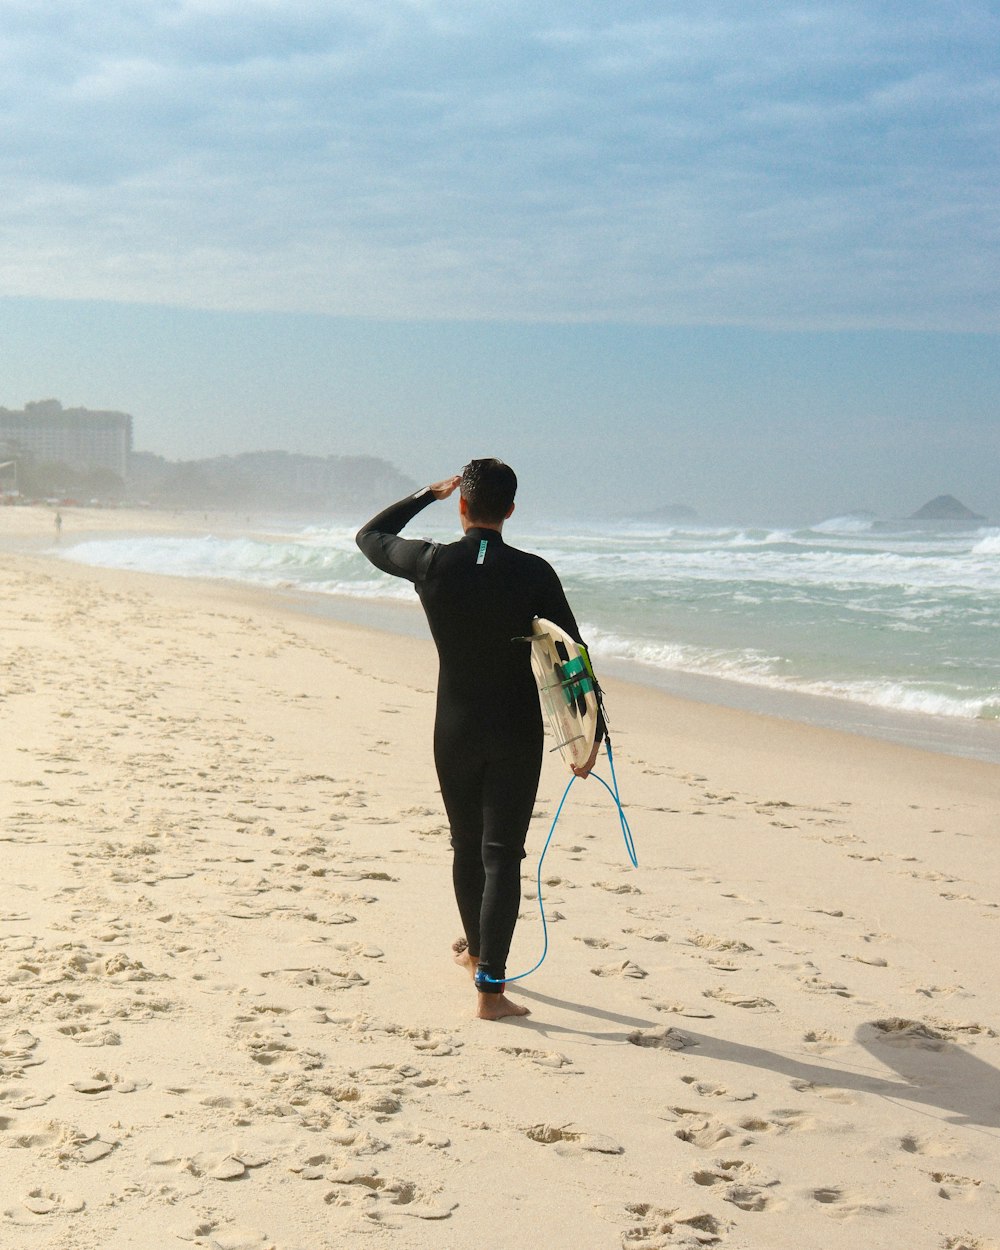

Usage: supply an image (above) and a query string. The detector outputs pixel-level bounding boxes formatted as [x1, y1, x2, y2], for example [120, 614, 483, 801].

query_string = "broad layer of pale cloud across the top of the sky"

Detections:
[0, 0, 1000, 329]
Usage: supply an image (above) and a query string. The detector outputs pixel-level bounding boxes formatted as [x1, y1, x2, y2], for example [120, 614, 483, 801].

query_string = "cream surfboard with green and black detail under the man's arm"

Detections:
[530, 616, 599, 768]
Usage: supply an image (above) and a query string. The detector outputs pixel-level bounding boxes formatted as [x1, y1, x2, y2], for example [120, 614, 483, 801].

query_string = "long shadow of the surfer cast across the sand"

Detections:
[521, 990, 1000, 1129]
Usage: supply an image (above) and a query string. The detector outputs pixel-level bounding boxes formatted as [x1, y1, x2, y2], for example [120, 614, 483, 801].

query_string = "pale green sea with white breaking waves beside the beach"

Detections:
[60, 514, 1000, 761]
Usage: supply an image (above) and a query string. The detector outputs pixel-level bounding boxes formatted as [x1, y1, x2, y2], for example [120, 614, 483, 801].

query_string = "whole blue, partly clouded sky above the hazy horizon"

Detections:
[0, 0, 1000, 521]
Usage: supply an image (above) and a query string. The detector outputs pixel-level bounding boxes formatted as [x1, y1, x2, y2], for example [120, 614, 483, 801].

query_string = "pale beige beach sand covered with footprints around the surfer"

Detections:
[0, 510, 1000, 1250]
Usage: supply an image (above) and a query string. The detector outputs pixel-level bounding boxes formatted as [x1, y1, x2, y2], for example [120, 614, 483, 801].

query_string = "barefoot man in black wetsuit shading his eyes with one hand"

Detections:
[358, 460, 603, 1020]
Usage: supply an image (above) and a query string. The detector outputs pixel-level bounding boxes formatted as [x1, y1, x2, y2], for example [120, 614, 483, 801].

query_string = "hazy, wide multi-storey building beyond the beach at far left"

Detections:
[0, 399, 133, 481]
